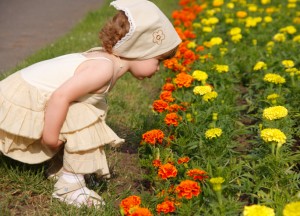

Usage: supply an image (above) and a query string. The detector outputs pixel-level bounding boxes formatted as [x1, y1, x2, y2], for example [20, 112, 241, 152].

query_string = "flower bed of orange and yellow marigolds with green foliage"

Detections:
[120, 0, 300, 216]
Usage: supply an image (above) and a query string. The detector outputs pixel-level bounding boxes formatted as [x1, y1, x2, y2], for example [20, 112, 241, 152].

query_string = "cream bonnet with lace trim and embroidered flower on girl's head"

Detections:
[110, 0, 181, 59]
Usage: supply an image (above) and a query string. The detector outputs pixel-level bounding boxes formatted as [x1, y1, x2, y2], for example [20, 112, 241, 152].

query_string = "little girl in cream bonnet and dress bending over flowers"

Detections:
[0, 0, 181, 206]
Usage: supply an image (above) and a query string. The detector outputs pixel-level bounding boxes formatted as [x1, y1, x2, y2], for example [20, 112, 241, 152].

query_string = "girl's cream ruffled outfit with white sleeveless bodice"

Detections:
[0, 53, 124, 175]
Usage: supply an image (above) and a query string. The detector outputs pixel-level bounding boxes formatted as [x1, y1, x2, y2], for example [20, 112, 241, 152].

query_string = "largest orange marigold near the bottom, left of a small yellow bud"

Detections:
[175, 180, 201, 199]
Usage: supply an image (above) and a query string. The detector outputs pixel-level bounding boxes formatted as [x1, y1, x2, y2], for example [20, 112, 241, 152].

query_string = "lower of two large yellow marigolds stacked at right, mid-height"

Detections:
[260, 128, 286, 146]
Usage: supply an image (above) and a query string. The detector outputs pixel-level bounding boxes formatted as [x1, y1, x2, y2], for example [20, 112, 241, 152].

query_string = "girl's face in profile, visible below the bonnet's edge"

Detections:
[130, 58, 160, 80]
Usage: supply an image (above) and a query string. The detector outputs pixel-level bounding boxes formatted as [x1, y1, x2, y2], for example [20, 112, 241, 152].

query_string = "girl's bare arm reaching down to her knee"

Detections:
[42, 60, 113, 148]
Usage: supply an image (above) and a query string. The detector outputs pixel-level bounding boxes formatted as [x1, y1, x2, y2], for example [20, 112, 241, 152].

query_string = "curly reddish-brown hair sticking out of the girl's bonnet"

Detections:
[99, 11, 130, 53]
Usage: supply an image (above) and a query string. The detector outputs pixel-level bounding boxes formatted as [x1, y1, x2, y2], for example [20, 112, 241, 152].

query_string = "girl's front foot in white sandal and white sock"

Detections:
[52, 178, 105, 208]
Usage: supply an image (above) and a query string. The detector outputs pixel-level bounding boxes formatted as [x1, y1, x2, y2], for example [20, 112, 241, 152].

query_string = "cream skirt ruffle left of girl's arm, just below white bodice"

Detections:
[0, 73, 50, 139]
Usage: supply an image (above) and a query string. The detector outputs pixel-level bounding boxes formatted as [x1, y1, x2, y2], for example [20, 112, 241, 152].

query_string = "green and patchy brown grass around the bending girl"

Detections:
[0, 0, 177, 216]
